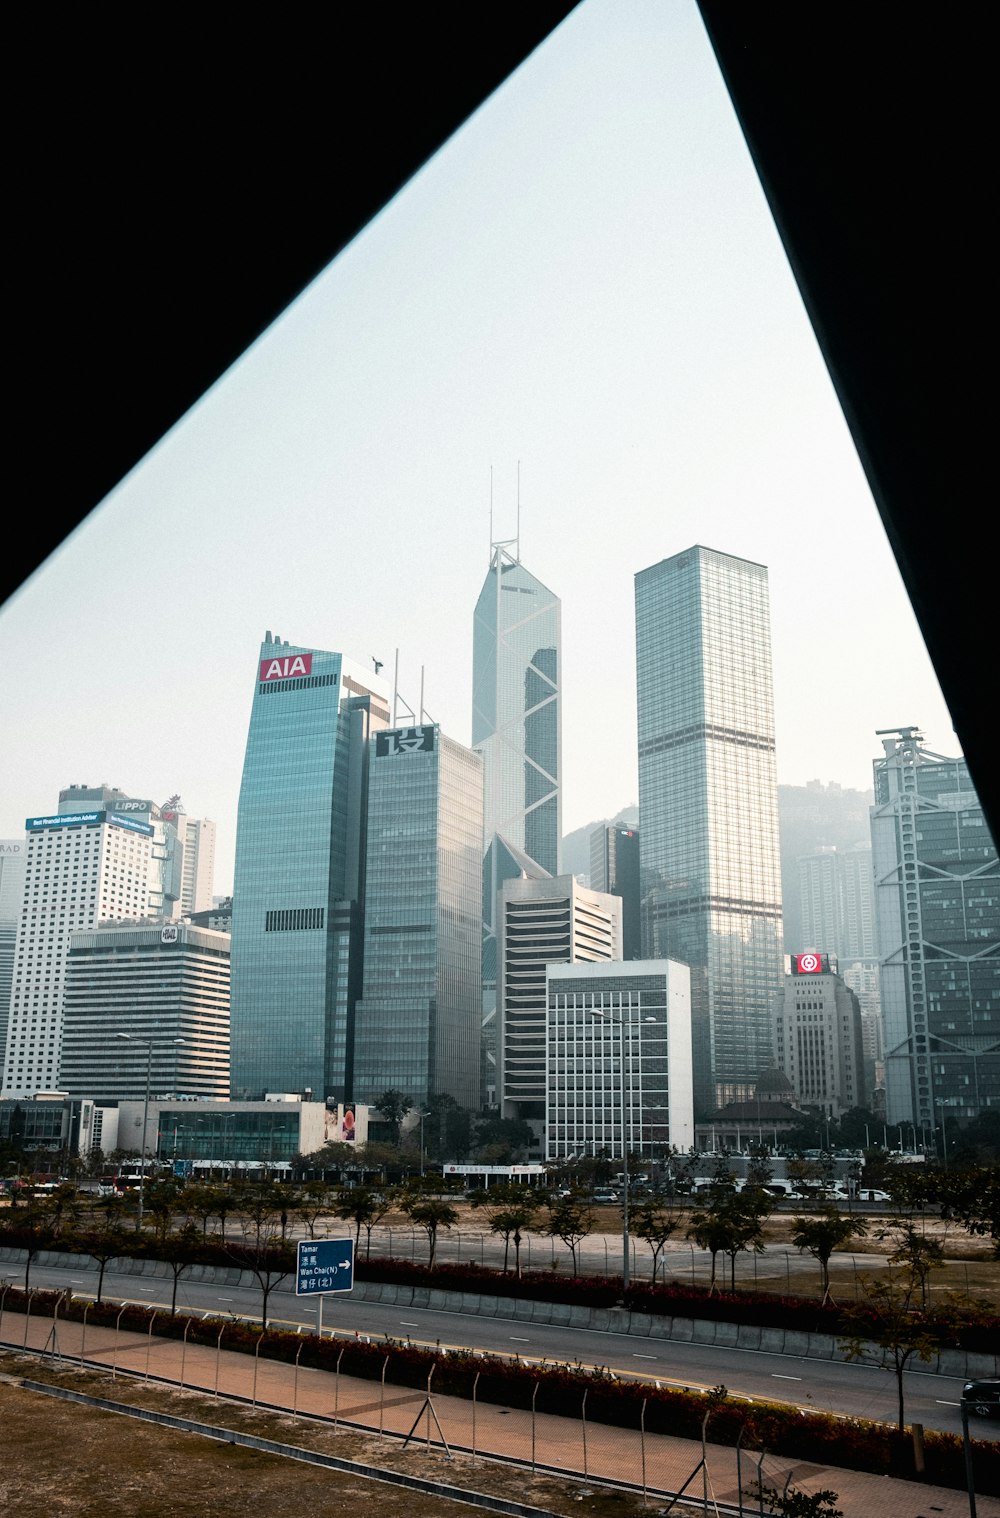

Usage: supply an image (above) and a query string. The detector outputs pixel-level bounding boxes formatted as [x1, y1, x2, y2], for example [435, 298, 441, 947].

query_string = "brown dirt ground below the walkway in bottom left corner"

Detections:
[0, 1354, 648, 1518]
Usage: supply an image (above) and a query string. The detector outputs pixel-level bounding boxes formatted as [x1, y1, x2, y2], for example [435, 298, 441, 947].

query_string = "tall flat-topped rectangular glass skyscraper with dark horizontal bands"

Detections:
[636, 546, 783, 1113]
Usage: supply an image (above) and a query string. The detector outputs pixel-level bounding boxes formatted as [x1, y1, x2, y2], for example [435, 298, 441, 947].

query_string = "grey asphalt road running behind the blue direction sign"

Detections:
[0, 1263, 1000, 1439]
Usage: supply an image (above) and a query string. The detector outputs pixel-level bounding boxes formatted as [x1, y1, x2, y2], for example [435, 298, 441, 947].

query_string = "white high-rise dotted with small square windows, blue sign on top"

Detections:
[3, 806, 155, 1096]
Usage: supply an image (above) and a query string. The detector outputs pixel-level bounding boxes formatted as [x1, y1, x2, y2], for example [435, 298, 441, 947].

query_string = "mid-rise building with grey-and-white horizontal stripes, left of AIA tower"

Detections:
[59, 918, 229, 1104]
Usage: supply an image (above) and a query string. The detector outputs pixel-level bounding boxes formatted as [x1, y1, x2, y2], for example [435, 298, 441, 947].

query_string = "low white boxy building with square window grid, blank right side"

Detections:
[545, 959, 695, 1160]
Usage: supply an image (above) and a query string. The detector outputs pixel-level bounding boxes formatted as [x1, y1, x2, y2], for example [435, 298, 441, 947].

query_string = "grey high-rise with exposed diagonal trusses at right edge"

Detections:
[871, 727, 1000, 1129]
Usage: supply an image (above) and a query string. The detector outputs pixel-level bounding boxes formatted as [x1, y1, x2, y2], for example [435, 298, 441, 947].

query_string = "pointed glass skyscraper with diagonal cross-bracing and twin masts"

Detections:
[472, 543, 563, 1096]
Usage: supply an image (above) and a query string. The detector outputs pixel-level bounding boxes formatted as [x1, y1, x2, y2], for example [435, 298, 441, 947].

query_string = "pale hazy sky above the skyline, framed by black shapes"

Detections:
[0, 0, 959, 894]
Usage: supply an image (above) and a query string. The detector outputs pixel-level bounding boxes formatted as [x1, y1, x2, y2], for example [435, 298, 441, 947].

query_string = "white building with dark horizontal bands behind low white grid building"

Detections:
[498, 874, 622, 1139]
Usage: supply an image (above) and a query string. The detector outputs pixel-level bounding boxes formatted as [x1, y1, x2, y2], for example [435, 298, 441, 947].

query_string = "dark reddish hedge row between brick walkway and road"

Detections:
[5, 1289, 1000, 1495]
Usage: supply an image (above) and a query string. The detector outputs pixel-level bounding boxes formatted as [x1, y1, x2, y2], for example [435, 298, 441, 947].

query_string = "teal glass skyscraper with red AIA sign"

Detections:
[231, 631, 390, 1101]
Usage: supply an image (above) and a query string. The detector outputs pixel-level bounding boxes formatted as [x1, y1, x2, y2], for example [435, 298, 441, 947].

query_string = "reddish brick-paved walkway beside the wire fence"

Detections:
[0, 1312, 1000, 1518]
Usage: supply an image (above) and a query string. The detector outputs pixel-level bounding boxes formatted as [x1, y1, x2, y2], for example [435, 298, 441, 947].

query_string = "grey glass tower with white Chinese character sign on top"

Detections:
[352, 724, 483, 1110]
